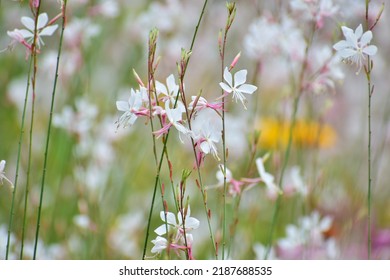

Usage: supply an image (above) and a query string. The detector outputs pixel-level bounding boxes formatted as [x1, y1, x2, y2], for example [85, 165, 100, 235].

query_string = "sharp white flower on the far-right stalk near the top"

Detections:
[333, 24, 378, 74]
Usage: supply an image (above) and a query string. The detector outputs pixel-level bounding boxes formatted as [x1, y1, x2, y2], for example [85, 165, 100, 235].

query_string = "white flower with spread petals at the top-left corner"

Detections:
[7, 13, 58, 48]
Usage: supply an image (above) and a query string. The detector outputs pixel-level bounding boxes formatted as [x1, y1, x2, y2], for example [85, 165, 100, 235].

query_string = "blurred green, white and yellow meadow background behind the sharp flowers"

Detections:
[0, 0, 390, 259]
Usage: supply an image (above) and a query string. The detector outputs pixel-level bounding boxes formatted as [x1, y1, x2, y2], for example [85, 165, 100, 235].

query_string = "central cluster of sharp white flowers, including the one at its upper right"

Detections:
[116, 68, 257, 164]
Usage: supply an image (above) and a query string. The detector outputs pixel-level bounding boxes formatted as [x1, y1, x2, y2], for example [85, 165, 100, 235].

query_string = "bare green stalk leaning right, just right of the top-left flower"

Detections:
[33, 0, 67, 260]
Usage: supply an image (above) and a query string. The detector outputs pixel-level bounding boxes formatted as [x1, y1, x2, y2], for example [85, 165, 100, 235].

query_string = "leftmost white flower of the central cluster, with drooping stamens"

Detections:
[116, 89, 142, 130]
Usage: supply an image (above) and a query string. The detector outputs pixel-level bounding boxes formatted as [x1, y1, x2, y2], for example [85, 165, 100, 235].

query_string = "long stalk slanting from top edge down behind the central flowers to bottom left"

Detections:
[142, 0, 208, 260]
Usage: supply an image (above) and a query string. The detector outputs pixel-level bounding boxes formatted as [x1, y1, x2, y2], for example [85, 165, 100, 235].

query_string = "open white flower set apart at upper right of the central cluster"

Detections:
[219, 67, 257, 109]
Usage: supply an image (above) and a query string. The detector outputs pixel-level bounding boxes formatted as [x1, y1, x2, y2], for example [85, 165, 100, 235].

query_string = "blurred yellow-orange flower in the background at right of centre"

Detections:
[258, 118, 336, 149]
